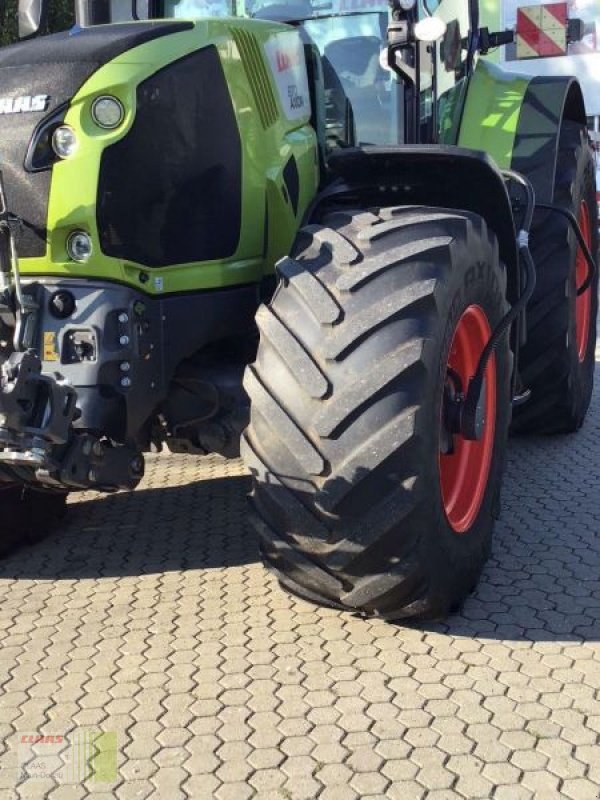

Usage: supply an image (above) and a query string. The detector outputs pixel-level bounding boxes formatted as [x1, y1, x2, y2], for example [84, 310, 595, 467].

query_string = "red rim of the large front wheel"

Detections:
[439, 305, 496, 533]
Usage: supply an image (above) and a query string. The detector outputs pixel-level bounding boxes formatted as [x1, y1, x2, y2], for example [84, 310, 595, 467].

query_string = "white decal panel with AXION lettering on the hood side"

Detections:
[265, 31, 310, 122]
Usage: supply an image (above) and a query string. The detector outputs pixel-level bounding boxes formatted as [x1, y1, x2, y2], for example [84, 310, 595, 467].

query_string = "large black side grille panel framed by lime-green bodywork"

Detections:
[97, 47, 242, 267]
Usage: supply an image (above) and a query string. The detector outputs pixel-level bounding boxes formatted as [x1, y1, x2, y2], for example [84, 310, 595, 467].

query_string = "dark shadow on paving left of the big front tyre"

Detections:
[0, 473, 258, 580]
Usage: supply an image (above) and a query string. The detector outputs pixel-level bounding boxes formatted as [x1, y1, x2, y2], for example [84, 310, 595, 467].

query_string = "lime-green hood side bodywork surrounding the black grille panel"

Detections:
[20, 18, 319, 294]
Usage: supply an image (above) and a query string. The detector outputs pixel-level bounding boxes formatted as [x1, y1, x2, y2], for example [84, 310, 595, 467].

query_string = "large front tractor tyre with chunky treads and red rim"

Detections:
[242, 207, 511, 619]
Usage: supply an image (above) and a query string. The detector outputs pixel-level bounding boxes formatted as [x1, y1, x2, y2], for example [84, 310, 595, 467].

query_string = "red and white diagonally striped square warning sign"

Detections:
[517, 3, 568, 58]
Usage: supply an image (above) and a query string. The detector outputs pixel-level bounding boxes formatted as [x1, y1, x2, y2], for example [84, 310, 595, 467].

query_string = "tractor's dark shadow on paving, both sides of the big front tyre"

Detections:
[0, 406, 600, 641]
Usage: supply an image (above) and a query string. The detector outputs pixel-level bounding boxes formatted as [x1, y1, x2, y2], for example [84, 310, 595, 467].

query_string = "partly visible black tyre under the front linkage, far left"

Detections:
[0, 483, 67, 557]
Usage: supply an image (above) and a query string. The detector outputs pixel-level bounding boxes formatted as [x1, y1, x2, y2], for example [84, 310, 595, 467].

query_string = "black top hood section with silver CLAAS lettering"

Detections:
[0, 22, 193, 257]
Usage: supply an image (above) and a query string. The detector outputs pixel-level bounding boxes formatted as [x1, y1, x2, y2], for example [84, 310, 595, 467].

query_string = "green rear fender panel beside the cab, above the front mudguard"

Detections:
[458, 59, 531, 169]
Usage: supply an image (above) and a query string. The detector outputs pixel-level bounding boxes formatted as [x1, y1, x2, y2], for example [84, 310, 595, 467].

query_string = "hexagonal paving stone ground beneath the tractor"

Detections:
[0, 358, 600, 800]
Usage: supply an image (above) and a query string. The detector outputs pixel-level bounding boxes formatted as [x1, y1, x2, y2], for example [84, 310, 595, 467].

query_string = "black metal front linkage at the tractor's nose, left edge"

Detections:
[0, 173, 144, 490]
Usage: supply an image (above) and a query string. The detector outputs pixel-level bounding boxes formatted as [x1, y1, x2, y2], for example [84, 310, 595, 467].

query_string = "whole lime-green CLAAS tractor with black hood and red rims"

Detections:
[0, 0, 598, 619]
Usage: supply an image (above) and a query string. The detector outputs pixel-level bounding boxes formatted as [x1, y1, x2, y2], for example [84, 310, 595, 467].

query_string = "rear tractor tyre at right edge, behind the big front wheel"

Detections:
[512, 120, 598, 433]
